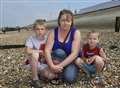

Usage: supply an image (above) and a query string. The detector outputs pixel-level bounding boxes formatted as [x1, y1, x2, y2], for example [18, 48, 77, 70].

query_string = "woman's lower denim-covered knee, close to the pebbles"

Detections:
[63, 64, 78, 83]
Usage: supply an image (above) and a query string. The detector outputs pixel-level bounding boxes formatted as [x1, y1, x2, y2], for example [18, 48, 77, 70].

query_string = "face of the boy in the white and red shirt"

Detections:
[34, 25, 47, 37]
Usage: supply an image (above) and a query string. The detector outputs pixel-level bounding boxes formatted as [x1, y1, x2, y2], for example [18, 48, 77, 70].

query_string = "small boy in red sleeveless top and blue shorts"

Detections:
[76, 31, 107, 76]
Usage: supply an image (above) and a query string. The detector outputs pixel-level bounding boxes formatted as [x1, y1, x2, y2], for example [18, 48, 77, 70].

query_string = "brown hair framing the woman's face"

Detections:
[58, 9, 74, 26]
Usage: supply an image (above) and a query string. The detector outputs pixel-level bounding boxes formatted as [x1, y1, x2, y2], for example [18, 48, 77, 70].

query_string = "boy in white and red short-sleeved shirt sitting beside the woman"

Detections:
[25, 21, 55, 88]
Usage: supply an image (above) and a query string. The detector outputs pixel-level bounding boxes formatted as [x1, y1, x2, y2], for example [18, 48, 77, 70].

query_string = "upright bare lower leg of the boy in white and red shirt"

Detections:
[31, 53, 39, 80]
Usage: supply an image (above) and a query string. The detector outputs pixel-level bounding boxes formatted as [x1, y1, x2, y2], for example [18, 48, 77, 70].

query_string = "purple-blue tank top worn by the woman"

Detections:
[52, 27, 76, 56]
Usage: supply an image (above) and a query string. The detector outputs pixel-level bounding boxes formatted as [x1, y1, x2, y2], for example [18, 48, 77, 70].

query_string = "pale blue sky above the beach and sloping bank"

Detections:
[0, 0, 110, 27]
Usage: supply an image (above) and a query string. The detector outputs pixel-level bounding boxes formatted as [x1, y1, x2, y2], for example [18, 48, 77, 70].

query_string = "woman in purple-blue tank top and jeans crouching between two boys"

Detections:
[45, 10, 80, 83]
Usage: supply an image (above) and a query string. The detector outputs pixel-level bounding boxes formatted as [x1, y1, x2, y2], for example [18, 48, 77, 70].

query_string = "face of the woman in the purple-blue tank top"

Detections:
[60, 14, 72, 30]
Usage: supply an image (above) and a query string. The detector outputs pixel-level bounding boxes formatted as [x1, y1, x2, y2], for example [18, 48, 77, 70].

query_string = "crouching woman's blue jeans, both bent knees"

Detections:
[52, 49, 79, 84]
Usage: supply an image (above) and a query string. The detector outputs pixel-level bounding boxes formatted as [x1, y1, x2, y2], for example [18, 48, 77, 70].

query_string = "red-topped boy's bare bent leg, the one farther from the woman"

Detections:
[93, 55, 105, 73]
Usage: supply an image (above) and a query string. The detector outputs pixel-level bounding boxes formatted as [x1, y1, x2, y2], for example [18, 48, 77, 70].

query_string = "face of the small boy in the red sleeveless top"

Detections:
[88, 33, 99, 48]
